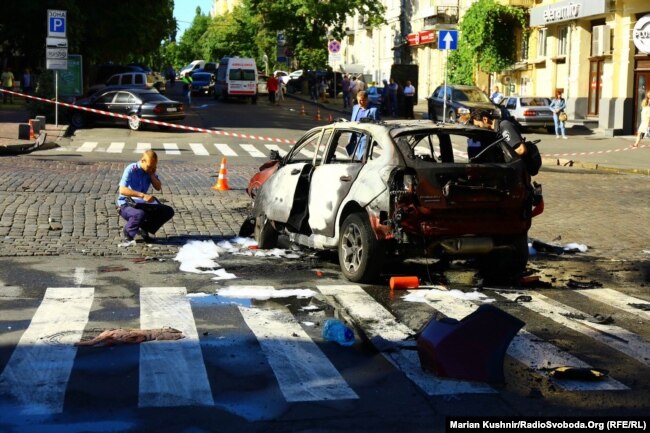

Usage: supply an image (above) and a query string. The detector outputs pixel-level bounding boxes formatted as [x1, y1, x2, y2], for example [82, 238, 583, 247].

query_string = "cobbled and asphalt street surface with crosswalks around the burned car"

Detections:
[0, 88, 650, 432]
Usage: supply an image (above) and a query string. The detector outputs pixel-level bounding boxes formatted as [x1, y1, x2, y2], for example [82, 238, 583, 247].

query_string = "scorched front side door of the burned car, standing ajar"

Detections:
[255, 129, 322, 224]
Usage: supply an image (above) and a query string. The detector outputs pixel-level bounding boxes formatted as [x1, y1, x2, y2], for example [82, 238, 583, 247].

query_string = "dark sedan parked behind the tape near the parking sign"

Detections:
[70, 87, 185, 130]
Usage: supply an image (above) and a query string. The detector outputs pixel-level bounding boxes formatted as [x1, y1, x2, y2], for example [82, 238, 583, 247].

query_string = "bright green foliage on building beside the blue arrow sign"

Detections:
[449, 0, 527, 84]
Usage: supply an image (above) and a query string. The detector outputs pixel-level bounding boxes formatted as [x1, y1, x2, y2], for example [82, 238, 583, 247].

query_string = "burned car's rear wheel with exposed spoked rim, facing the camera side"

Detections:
[338, 213, 383, 282]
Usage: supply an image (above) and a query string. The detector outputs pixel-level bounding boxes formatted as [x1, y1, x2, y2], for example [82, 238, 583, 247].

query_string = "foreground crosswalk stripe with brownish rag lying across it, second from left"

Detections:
[138, 287, 214, 407]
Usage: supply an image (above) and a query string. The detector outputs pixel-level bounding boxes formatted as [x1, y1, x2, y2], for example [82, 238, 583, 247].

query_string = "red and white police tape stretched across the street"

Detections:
[0, 89, 650, 158]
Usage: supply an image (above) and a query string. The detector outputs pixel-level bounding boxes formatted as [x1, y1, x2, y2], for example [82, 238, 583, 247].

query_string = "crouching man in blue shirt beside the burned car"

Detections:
[117, 150, 174, 242]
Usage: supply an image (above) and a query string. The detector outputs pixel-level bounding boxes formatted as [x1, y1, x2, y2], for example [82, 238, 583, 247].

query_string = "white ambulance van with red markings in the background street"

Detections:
[214, 57, 257, 104]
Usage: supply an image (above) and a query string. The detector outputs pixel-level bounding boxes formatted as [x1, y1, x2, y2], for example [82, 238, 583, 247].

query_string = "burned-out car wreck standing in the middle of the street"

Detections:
[240, 121, 543, 282]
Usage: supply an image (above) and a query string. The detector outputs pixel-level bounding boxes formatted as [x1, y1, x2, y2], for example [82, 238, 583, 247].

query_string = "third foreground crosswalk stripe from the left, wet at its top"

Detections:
[239, 298, 359, 402]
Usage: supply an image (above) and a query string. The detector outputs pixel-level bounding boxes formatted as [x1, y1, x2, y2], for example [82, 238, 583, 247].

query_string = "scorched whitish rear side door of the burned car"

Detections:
[309, 128, 372, 237]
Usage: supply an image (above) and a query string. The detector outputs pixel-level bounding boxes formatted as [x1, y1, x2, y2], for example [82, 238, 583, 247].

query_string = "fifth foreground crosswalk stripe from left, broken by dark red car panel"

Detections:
[418, 290, 628, 391]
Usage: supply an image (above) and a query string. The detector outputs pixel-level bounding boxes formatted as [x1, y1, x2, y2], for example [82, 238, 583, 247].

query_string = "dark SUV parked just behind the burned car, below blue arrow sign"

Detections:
[427, 85, 501, 123]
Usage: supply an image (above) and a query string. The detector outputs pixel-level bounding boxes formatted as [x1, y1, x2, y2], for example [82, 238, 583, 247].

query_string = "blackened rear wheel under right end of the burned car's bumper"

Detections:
[480, 233, 528, 279]
